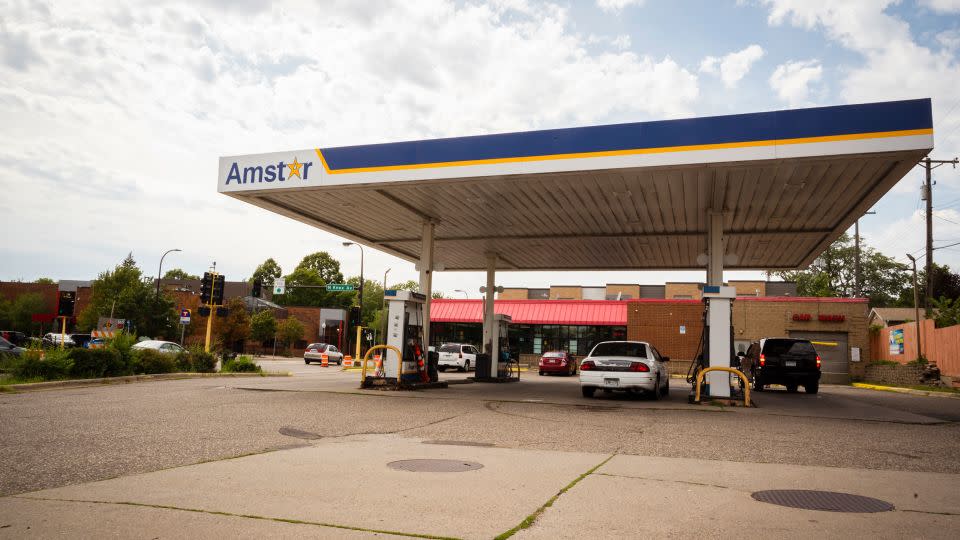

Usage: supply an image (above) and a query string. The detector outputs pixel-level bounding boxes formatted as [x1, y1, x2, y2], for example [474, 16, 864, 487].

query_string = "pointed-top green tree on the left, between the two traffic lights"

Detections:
[79, 253, 177, 337]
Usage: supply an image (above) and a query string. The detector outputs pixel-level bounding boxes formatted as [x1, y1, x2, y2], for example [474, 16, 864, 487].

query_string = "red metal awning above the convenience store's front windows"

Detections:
[430, 298, 627, 326]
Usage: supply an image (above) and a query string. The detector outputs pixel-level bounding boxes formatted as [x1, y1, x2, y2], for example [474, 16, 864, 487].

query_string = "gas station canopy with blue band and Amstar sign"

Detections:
[218, 99, 933, 271]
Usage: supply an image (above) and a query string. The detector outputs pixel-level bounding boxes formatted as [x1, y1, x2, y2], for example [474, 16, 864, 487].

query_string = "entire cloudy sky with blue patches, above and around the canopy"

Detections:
[0, 0, 960, 297]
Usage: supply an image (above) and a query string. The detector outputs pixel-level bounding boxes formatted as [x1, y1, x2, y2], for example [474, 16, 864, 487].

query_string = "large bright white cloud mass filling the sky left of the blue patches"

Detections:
[0, 0, 699, 281]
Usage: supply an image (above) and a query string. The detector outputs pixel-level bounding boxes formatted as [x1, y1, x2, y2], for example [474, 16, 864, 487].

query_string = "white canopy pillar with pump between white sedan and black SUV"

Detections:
[704, 211, 736, 397]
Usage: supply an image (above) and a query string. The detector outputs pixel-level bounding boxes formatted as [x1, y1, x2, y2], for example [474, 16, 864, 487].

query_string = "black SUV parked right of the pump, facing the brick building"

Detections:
[741, 338, 820, 394]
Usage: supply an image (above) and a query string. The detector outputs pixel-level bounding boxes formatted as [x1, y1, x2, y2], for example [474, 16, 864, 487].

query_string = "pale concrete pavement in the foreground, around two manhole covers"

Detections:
[0, 435, 960, 538]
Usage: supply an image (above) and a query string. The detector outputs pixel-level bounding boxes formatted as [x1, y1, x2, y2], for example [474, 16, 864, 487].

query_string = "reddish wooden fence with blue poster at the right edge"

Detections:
[870, 320, 960, 377]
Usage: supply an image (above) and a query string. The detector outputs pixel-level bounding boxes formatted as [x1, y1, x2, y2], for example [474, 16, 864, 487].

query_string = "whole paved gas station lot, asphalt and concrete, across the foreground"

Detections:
[0, 360, 960, 538]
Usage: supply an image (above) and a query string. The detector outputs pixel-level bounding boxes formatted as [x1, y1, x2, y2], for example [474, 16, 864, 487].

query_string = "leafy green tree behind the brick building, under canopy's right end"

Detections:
[772, 234, 912, 307]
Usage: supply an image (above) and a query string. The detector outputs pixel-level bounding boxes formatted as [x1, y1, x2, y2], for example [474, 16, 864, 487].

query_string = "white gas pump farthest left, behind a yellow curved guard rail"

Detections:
[383, 290, 429, 383]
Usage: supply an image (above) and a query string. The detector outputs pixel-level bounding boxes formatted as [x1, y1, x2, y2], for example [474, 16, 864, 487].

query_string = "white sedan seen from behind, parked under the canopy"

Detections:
[580, 341, 670, 399]
